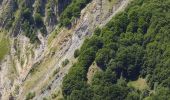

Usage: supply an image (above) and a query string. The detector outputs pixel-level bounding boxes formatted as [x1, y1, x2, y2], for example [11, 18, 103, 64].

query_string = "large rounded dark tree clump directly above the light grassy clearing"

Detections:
[115, 44, 144, 80]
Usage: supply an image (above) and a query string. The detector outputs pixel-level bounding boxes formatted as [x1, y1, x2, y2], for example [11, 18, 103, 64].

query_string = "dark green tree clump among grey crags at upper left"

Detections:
[21, 5, 46, 43]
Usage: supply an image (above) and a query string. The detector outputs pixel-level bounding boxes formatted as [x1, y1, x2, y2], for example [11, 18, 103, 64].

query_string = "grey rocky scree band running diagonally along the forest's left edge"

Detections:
[34, 0, 129, 99]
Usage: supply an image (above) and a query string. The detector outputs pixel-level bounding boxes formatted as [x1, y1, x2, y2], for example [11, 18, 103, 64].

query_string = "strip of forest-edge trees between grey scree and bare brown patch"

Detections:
[62, 38, 101, 98]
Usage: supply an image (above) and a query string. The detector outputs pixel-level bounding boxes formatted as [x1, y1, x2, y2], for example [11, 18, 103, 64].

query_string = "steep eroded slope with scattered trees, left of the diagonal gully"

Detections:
[0, 0, 90, 99]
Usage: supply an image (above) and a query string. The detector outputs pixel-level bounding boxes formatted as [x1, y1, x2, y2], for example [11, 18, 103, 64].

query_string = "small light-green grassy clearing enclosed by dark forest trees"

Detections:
[128, 78, 148, 90]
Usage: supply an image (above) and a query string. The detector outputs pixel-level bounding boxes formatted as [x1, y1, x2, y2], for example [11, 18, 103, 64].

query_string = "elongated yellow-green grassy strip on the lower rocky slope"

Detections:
[23, 54, 56, 94]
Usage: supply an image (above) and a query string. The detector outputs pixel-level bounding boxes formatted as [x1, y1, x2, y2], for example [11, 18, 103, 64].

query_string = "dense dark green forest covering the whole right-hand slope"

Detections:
[62, 0, 170, 100]
